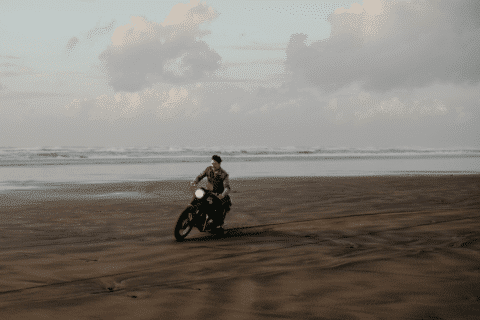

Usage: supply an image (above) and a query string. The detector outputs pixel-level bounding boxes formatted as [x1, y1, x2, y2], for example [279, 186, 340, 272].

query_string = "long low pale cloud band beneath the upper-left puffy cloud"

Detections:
[63, 75, 304, 122]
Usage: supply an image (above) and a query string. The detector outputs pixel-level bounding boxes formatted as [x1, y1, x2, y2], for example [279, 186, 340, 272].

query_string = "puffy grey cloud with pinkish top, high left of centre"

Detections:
[99, 0, 221, 92]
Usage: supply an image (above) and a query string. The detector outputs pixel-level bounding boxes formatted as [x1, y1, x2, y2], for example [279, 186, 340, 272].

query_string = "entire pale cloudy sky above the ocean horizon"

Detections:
[0, 0, 480, 148]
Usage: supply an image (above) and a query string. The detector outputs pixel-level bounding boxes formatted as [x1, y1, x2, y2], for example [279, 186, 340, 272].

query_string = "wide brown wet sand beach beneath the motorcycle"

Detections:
[0, 175, 480, 319]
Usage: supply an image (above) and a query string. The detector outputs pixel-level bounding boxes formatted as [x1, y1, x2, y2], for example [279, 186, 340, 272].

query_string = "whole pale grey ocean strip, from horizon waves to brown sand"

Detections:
[0, 147, 480, 192]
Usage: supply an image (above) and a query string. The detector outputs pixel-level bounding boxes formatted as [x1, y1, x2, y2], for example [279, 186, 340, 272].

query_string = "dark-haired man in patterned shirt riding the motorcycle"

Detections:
[191, 155, 232, 227]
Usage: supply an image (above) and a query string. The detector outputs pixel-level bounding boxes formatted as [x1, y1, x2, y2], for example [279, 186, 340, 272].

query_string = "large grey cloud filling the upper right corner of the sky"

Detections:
[286, 0, 480, 92]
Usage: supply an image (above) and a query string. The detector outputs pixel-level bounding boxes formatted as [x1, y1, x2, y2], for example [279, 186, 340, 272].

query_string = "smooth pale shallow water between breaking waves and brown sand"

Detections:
[0, 156, 480, 189]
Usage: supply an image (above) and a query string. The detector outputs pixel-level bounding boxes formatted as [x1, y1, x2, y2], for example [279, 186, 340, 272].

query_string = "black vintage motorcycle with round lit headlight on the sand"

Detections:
[174, 188, 224, 241]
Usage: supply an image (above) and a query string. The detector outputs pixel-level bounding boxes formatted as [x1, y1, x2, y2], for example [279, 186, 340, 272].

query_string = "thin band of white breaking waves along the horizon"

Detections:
[0, 146, 480, 165]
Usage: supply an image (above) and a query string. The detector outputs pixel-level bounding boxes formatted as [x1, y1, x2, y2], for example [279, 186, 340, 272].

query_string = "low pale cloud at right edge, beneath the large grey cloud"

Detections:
[317, 83, 480, 131]
